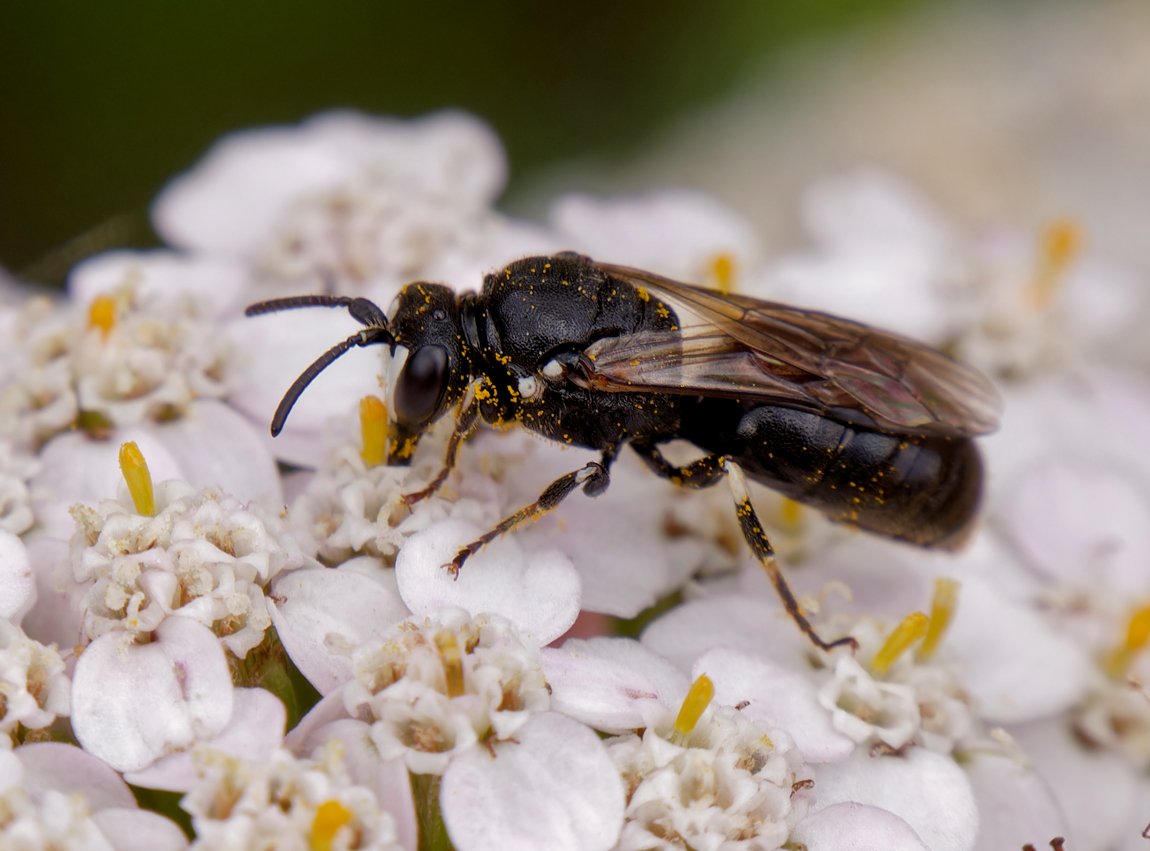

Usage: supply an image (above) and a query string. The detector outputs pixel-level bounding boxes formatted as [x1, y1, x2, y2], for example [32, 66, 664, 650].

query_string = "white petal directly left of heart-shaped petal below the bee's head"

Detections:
[271, 568, 409, 695]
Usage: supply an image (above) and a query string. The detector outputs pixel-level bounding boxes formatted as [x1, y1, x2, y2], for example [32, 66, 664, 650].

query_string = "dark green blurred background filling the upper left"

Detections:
[0, 0, 928, 284]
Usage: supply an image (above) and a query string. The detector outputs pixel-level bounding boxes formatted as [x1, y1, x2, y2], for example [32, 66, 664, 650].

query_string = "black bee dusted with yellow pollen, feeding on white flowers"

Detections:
[247, 253, 998, 649]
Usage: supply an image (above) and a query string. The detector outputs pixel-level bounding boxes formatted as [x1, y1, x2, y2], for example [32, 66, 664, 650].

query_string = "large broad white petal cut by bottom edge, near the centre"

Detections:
[440, 712, 623, 851]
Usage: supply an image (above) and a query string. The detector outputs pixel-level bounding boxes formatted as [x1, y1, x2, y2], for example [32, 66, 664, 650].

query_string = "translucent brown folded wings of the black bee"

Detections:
[584, 263, 1001, 437]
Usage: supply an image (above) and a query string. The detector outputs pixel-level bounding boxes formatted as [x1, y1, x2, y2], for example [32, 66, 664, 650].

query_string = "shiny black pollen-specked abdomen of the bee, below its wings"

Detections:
[734, 405, 982, 547]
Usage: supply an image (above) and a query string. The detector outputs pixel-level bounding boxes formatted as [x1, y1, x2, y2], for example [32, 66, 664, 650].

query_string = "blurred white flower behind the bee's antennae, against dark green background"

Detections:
[154, 113, 529, 292]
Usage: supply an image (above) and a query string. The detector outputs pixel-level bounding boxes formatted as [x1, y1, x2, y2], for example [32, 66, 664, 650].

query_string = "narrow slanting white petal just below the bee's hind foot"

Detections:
[691, 650, 854, 762]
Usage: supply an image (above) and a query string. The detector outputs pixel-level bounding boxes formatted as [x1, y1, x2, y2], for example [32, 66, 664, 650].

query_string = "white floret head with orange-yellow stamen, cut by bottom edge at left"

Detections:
[182, 745, 401, 851]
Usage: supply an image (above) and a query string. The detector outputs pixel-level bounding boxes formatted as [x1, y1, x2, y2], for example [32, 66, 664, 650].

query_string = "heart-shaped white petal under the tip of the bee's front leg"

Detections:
[396, 520, 580, 644]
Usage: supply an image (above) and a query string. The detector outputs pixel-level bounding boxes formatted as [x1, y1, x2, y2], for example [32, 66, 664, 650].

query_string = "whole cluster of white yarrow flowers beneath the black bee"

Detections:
[0, 106, 1150, 851]
